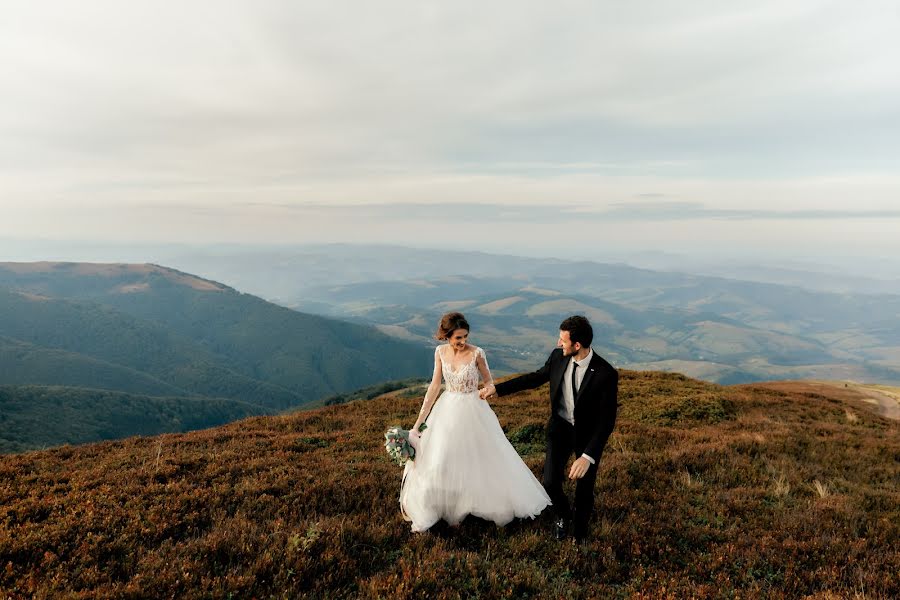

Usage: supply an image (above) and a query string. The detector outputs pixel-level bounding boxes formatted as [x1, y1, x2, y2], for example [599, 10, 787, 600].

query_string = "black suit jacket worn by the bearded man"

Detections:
[496, 348, 619, 462]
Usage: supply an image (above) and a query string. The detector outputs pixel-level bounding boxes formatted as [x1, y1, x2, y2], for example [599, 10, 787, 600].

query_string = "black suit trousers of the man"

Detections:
[542, 414, 597, 537]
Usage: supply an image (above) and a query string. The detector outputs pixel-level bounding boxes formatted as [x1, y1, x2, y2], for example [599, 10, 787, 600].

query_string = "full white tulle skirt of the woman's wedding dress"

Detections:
[400, 391, 550, 531]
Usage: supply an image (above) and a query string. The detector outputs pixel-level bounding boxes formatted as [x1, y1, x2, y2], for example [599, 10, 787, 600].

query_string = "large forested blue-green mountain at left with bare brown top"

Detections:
[0, 263, 431, 452]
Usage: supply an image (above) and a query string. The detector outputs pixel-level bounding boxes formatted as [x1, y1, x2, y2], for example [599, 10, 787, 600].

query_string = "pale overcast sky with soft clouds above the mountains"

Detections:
[0, 0, 900, 256]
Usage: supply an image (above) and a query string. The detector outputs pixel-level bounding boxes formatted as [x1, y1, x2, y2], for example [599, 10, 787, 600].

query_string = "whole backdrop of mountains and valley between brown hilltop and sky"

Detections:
[0, 246, 900, 451]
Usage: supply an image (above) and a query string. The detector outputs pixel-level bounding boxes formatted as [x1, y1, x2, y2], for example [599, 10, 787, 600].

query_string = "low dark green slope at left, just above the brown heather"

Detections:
[0, 385, 271, 454]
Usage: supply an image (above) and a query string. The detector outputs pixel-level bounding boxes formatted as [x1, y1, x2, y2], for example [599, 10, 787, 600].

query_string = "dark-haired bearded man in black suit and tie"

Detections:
[482, 316, 619, 541]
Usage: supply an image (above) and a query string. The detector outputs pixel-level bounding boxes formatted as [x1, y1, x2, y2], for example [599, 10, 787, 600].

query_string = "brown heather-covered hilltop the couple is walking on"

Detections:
[0, 371, 900, 600]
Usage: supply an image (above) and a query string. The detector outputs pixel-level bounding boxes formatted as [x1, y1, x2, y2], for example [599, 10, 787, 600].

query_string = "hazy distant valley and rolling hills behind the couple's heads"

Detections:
[158, 245, 900, 383]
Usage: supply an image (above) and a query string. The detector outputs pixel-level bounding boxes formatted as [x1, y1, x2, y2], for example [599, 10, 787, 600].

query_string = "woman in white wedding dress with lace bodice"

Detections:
[400, 312, 550, 532]
